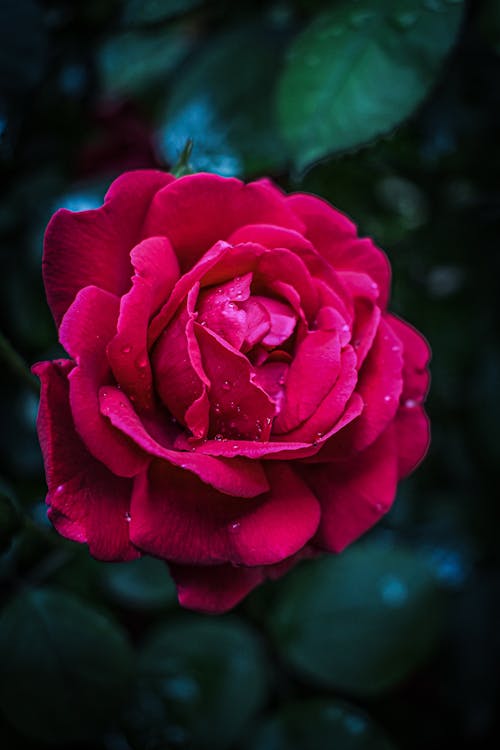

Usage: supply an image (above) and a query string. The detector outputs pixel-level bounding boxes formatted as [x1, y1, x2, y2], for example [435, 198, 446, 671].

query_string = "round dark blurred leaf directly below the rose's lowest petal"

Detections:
[126, 615, 267, 750]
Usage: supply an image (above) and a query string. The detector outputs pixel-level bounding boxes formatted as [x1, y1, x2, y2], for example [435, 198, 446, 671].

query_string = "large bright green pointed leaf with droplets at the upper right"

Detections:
[277, 0, 463, 169]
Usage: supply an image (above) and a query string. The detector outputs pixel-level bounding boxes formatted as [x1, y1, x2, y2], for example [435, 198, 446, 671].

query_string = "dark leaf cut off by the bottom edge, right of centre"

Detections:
[248, 698, 392, 750]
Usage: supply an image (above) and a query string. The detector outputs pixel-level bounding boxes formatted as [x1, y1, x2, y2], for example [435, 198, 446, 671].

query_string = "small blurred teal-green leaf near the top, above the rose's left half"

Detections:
[98, 28, 191, 97]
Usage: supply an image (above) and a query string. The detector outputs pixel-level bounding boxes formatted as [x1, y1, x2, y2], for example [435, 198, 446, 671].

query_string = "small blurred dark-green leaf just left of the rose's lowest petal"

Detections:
[102, 557, 177, 609]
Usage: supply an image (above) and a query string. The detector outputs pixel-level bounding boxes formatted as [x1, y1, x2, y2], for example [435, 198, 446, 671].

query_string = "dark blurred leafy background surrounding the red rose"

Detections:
[0, 0, 500, 750]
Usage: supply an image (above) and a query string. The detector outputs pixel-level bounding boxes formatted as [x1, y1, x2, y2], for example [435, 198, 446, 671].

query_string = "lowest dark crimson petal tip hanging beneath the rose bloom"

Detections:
[169, 564, 265, 615]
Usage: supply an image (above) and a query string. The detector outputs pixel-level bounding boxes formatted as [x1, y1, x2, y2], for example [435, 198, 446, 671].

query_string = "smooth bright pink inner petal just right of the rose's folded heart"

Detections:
[273, 331, 340, 433]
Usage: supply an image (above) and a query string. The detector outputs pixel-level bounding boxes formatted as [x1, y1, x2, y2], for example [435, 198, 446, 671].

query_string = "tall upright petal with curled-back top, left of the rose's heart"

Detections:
[107, 237, 179, 409]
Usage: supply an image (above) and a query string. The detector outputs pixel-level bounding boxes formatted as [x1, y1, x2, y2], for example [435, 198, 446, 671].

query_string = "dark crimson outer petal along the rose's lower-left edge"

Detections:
[33, 360, 140, 560]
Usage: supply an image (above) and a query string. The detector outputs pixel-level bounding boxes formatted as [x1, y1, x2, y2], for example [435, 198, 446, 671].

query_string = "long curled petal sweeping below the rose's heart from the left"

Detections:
[100, 386, 269, 497]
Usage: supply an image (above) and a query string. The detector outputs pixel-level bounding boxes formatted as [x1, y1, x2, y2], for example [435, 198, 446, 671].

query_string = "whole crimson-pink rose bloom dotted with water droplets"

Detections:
[34, 170, 429, 612]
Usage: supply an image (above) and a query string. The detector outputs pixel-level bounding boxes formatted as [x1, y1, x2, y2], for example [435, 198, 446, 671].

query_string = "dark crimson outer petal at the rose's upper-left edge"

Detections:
[43, 170, 174, 326]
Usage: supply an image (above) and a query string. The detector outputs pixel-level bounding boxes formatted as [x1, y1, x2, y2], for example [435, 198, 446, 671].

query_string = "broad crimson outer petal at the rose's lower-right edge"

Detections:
[303, 426, 398, 552]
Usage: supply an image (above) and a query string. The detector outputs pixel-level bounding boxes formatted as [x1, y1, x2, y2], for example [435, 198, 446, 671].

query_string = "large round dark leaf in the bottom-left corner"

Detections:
[0, 588, 131, 742]
